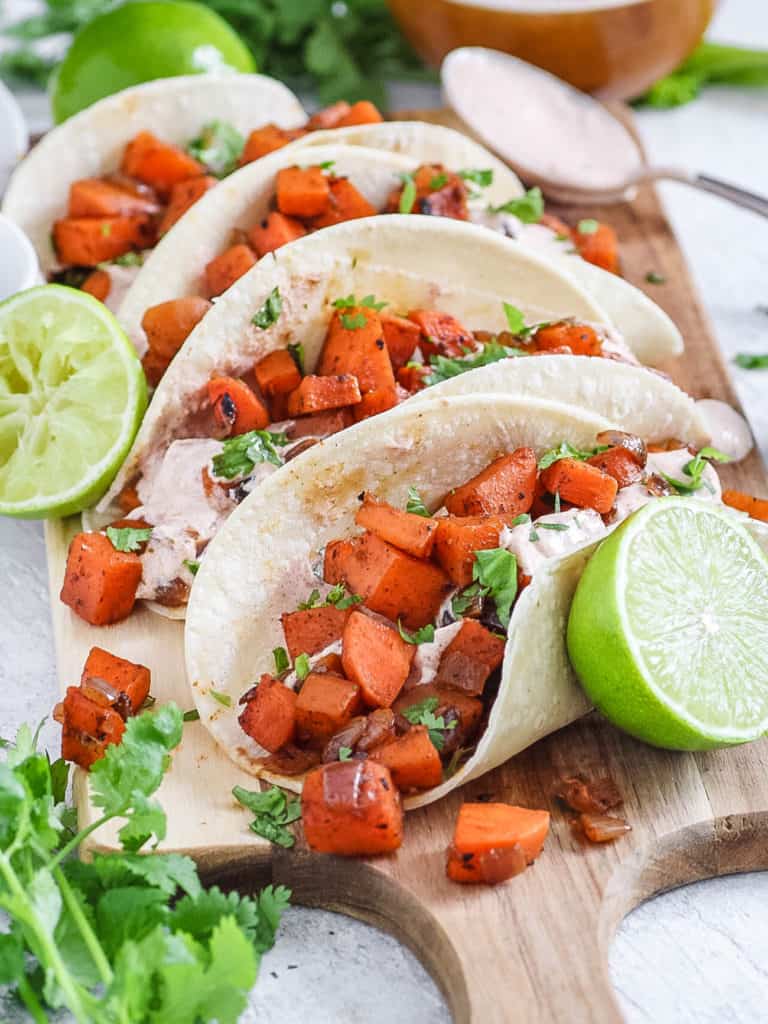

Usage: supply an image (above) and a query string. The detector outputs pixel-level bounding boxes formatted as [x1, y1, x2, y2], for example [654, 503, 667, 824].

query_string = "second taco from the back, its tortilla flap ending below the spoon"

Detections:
[119, 122, 682, 374]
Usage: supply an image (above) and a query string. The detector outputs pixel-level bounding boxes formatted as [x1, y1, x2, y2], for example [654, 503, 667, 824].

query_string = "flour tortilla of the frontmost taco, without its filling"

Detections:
[185, 394, 610, 808]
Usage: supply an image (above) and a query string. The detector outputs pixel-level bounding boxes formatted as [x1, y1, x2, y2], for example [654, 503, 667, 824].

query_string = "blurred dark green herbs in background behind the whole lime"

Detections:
[0, 0, 436, 108]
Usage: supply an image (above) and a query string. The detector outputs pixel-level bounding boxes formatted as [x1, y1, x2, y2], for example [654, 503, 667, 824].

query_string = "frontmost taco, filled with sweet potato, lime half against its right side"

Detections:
[185, 393, 757, 807]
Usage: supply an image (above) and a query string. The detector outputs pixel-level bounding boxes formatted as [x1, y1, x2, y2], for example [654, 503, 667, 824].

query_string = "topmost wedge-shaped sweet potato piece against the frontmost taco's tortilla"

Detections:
[445, 449, 538, 516]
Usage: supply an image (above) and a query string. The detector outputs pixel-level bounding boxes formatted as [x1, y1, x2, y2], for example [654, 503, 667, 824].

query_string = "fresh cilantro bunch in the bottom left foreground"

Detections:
[0, 705, 290, 1024]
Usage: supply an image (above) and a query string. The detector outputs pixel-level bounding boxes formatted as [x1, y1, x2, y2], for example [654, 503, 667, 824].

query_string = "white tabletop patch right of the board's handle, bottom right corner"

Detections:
[609, 871, 768, 1024]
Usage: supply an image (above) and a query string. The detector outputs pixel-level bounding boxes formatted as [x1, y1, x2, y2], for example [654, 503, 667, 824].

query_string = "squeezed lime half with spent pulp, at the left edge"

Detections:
[0, 285, 146, 519]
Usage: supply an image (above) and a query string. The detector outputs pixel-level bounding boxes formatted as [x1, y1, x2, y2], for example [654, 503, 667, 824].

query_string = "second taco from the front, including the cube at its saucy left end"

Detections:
[62, 216, 707, 625]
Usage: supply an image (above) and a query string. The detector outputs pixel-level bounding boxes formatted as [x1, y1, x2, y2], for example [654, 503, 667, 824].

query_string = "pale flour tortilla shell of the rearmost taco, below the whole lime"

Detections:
[2, 74, 306, 273]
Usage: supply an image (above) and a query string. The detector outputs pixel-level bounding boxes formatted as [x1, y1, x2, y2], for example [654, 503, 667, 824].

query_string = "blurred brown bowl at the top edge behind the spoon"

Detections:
[388, 0, 717, 99]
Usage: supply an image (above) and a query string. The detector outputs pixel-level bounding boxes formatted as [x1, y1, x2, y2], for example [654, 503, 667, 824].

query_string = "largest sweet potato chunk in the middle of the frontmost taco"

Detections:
[326, 532, 451, 630]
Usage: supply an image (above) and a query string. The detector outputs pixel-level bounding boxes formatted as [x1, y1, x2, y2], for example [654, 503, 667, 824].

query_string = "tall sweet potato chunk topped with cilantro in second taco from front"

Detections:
[317, 306, 394, 395]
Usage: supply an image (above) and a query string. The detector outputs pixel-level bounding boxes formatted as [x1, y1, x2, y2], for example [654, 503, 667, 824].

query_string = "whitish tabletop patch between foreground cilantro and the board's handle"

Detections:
[252, 906, 451, 1024]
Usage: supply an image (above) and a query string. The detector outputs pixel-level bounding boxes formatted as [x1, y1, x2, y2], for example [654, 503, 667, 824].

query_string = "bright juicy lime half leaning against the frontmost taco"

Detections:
[568, 498, 768, 751]
